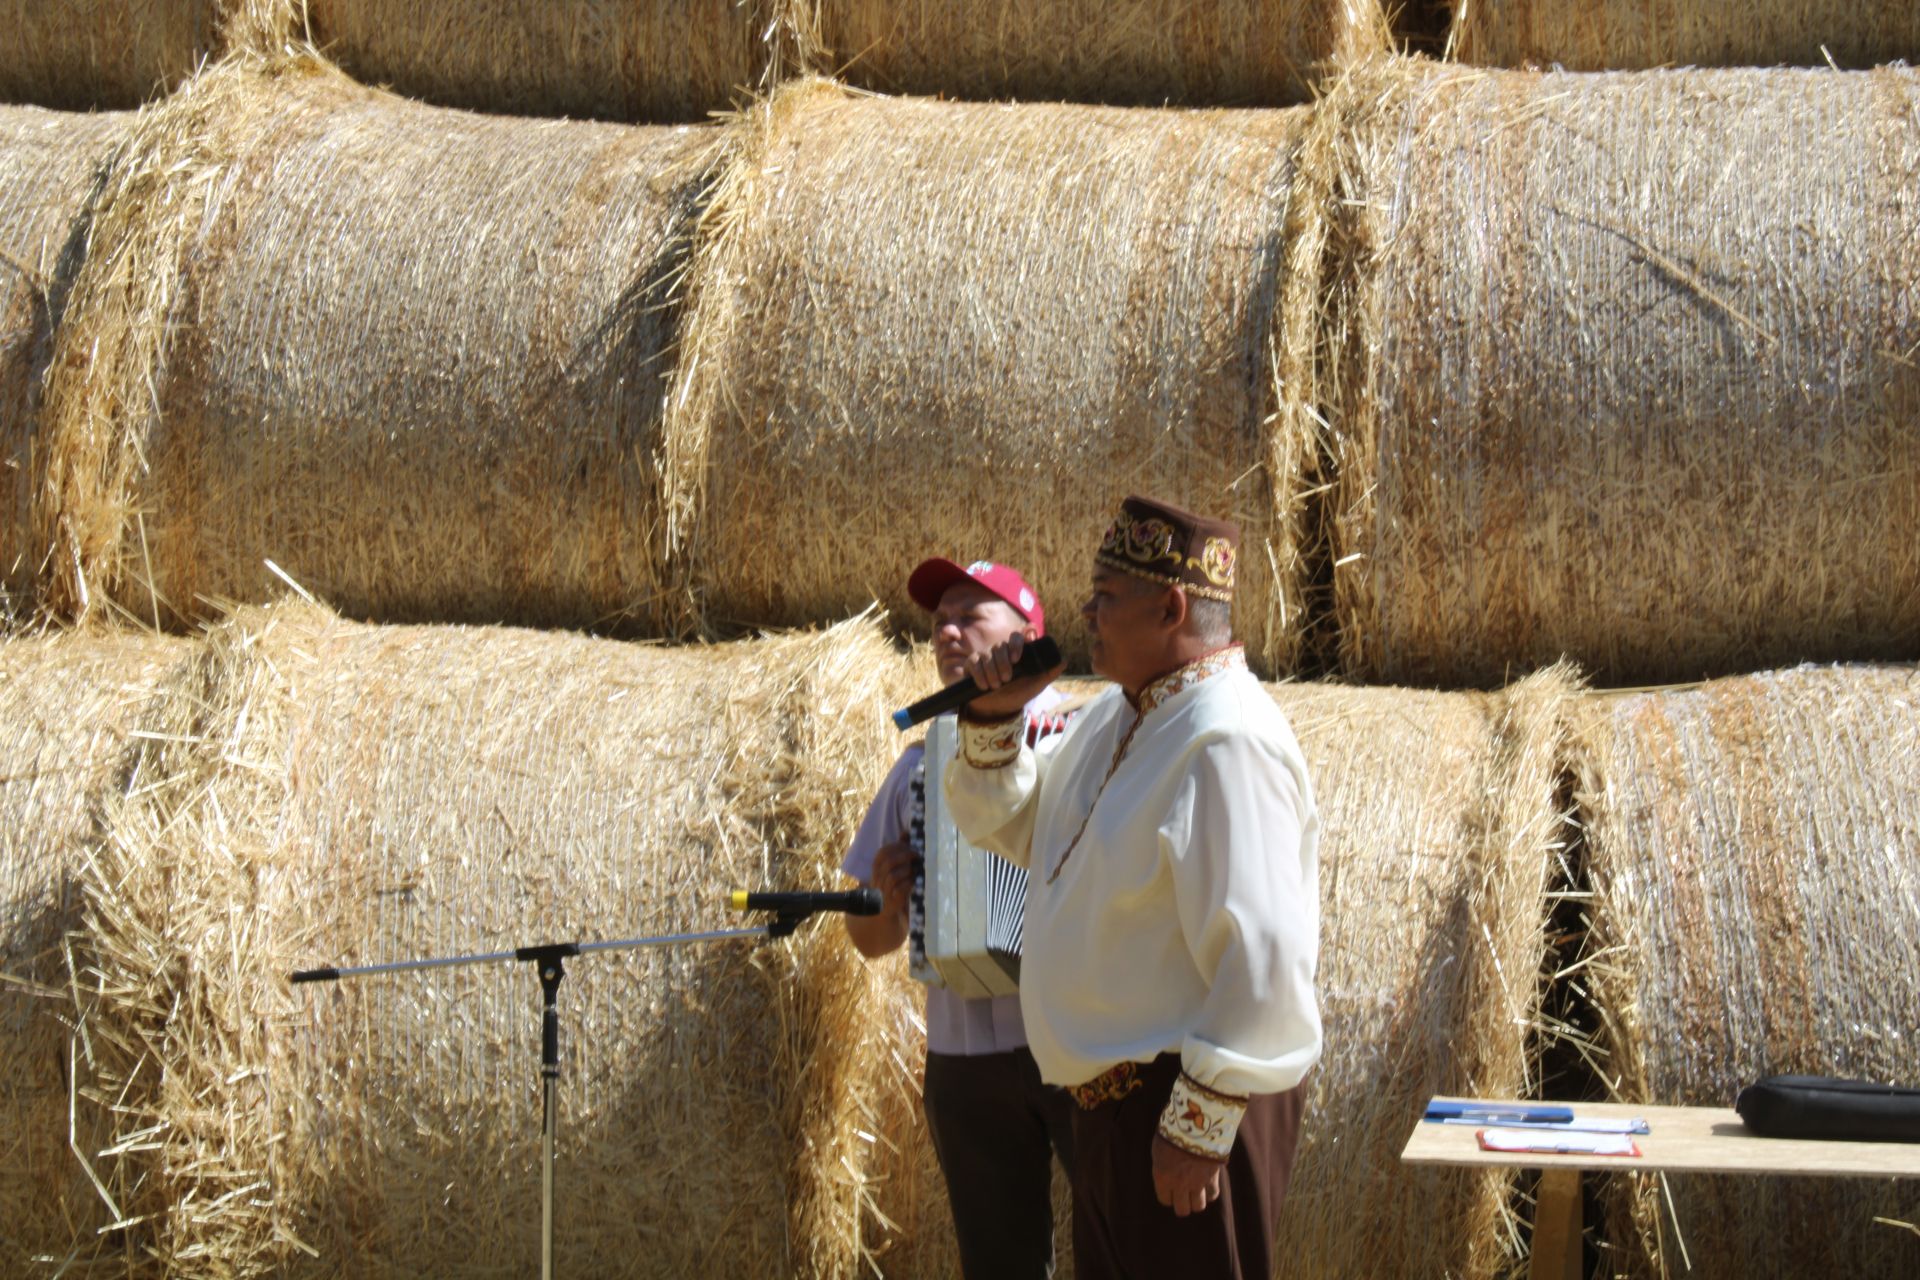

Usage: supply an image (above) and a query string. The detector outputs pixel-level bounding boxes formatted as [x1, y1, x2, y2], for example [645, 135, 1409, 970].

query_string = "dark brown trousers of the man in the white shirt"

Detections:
[1073, 1054, 1302, 1280]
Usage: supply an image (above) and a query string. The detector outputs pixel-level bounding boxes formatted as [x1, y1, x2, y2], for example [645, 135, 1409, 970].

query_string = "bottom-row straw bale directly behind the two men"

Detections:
[877, 668, 1574, 1276]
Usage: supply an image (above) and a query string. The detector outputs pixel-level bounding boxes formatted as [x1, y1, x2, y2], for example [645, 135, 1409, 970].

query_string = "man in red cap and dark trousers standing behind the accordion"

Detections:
[841, 558, 1073, 1280]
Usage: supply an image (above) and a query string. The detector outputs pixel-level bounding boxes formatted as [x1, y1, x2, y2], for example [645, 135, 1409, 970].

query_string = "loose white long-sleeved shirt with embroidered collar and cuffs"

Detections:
[945, 647, 1321, 1157]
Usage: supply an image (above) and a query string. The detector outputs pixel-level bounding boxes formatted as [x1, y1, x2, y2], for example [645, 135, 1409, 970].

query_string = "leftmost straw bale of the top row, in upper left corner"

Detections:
[0, 0, 292, 111]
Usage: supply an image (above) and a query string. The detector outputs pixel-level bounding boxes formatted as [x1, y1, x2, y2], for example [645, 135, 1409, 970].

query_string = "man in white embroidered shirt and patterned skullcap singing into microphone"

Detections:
[945, 497, 1321, 1280]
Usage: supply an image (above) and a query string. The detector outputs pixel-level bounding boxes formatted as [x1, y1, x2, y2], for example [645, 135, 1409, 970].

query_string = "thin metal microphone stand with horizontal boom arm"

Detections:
[292, 906, 818, 1280]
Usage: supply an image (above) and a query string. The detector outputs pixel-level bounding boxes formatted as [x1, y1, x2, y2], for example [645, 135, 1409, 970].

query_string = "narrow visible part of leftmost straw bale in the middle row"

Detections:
[0, 107, 132, 622]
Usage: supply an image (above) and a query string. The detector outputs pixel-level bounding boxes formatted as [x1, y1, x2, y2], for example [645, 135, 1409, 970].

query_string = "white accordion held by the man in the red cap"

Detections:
[908, 716, 1027, 1000]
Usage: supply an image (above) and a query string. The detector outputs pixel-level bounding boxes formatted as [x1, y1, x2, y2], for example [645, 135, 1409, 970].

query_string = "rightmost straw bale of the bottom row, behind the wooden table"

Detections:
[1576, 666, 1920, 1278]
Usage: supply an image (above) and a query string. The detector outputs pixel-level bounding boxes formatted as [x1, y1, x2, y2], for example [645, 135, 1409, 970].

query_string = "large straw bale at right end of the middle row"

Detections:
[1323, 63, 1920, 683]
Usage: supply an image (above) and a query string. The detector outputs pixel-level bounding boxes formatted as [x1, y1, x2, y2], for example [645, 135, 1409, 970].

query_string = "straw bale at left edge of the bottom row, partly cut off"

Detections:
[0, 635, 186, 1274]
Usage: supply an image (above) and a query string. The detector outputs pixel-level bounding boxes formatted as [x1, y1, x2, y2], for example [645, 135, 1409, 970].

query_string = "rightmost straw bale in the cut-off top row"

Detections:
[1452, 0, 1920, 71]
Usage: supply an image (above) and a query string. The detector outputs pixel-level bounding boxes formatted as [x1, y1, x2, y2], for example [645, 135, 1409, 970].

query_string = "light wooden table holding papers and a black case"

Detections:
[1400, 1098, 1920, 1280]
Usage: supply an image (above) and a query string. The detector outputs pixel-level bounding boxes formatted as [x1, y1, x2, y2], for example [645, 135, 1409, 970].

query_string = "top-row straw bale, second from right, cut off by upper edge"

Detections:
[793, 0, 1388, 106]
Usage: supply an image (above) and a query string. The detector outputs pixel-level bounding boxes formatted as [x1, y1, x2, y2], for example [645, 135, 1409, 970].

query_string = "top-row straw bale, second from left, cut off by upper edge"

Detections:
[305, 0, 780, 121]
